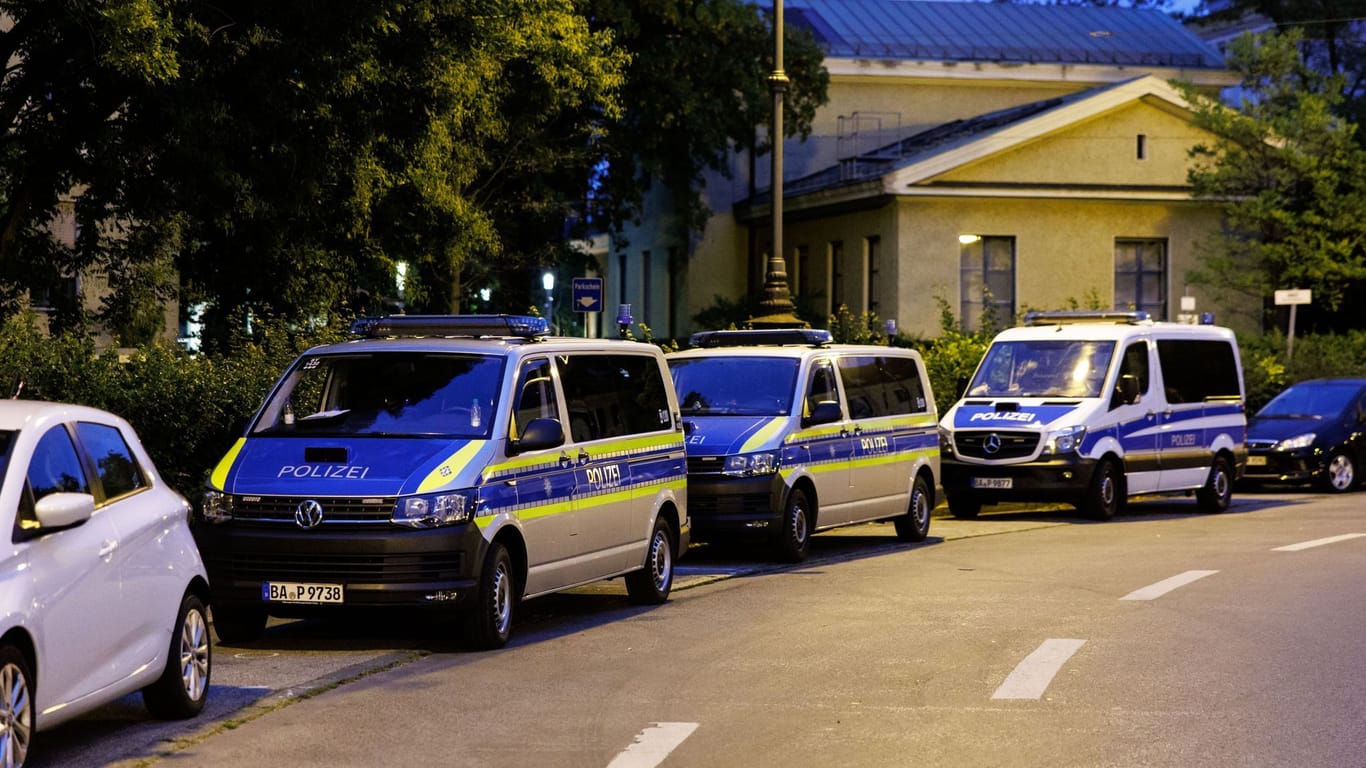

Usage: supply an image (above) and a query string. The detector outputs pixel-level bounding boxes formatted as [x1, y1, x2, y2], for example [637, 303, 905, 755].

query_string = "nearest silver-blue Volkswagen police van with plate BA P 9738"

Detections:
[195, 316, 690, 648]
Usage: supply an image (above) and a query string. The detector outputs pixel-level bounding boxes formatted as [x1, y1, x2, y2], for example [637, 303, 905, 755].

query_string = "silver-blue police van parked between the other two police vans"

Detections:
[668, 329, 938, 562]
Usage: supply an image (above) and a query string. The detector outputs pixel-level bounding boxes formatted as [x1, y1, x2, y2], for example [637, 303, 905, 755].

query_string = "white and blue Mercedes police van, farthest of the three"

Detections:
[941, 312, 1247, 519]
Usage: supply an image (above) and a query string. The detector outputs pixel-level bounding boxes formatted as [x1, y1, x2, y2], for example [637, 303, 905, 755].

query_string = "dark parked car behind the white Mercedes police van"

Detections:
[1243, 379, 1366, 493]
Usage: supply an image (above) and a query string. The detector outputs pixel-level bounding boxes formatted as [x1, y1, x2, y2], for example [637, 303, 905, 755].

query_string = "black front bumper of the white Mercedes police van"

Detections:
[940, 454, 1098, 504]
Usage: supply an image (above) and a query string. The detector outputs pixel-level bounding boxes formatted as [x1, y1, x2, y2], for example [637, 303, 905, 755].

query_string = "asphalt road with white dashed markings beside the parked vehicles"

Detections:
[33, 493, 1366, 768]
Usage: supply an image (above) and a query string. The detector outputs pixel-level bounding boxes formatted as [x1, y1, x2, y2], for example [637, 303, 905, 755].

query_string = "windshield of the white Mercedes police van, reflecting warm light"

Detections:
[967, 340, 1115, 398]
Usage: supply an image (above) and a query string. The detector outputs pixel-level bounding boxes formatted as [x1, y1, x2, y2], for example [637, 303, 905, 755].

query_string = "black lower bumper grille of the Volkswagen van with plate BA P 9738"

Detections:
[209, 552, 463, 584]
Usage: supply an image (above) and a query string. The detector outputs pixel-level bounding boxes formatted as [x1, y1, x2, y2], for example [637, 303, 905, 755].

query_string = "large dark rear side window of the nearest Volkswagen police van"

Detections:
[555, 354, 673, 443]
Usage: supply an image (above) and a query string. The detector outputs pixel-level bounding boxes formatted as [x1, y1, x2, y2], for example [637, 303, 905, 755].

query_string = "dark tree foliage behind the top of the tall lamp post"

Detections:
[582, 0, 829, 248]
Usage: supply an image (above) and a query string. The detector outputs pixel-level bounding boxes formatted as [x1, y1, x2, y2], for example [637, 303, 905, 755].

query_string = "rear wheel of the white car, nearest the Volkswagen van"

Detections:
[142, 593, 213, 720]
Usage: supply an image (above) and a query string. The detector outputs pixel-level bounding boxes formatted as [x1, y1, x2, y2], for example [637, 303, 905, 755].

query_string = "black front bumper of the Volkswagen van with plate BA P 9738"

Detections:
[194, 522, 488, 616]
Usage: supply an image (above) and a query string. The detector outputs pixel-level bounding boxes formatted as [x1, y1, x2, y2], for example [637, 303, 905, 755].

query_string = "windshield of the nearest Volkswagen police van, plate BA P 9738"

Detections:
[253, 353, 503, 437]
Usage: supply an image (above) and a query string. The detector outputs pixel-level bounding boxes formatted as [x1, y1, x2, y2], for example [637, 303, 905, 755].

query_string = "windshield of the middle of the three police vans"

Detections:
[669, 357, 798, 415]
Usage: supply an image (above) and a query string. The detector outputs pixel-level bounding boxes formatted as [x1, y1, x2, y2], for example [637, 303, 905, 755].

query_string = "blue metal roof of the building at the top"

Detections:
[783, 0, 1224, 70]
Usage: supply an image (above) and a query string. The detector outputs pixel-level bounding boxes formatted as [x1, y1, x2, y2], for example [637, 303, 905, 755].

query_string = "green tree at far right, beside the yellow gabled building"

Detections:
[1184, 30, 1366, 327]
